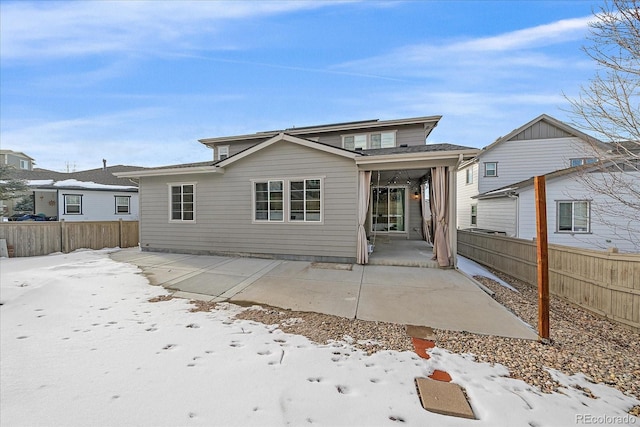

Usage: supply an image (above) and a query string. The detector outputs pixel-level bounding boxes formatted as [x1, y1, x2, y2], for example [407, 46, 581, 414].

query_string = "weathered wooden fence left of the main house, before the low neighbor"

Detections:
[0, 220, 138, 257]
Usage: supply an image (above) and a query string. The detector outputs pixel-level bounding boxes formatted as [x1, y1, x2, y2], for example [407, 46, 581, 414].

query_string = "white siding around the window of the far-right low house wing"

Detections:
[518, 174, 640, 252]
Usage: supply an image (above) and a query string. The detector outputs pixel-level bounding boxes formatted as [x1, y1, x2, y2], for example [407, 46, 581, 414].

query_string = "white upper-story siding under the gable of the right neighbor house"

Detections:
[478, 137, 593, 193]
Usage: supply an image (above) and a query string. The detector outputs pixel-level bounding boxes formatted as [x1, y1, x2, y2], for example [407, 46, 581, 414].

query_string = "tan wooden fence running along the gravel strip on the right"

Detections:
[458, 230, 640, 331]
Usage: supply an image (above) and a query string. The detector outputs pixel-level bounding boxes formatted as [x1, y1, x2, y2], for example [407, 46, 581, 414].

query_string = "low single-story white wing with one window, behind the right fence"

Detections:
[476, 163, 640, 253]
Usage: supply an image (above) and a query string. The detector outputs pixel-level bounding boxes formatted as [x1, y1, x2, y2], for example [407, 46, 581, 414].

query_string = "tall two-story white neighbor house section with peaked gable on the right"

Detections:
[457, 114, 608, 236]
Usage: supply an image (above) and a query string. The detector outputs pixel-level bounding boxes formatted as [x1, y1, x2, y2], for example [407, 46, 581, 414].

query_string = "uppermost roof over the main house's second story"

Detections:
[198, 116, 442, 144]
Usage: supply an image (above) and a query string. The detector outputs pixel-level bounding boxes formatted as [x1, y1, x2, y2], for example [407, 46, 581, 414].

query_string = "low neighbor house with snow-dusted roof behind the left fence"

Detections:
[6, 163, 140, 221]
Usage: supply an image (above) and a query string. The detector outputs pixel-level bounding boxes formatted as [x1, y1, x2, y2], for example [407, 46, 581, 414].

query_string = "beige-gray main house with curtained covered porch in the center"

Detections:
[116, 116, 478, 266]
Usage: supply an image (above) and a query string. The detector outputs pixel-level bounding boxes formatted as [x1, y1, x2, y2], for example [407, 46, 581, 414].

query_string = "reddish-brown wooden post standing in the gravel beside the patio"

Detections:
[533, 176, 550, 343]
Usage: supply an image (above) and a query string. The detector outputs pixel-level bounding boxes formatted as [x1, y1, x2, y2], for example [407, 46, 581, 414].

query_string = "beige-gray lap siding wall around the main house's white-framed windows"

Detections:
[141, 142, 358, 259]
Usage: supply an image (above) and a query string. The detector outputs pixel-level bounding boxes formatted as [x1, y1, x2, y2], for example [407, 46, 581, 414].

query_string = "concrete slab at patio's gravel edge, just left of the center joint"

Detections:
[230, 276, 360, 319]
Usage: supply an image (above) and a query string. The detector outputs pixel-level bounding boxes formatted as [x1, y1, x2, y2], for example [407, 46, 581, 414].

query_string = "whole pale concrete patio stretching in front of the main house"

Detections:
[111, 248, 537, 340]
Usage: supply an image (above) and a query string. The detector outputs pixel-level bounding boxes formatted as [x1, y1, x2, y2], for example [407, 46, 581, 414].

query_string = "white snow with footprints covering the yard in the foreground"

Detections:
[0, 250, 640, 427]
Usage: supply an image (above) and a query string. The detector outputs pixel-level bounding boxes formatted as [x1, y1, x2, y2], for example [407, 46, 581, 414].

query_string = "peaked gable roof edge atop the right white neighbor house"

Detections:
[478, 114, 609, 157]
